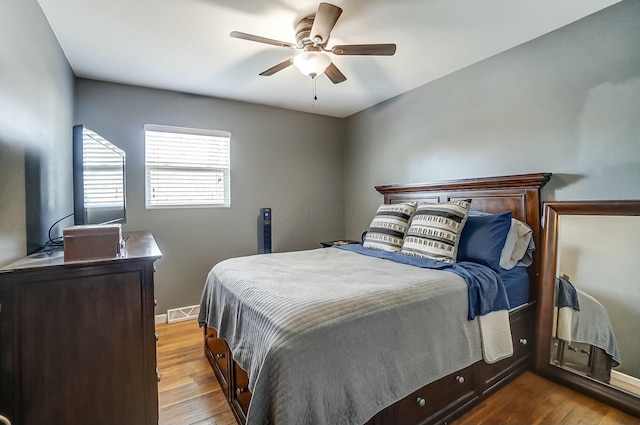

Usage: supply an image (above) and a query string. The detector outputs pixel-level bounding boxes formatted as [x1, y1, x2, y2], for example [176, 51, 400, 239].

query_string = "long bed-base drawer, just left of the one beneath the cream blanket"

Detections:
[393, 366, 476, 425]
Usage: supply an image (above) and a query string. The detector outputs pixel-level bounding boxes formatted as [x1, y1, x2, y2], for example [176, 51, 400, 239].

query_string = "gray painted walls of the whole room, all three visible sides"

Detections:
[0, 0, 640, 318]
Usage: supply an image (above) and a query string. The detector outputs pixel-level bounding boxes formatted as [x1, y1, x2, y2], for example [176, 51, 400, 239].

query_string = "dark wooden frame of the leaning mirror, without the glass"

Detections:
[534, 200, 640, 416]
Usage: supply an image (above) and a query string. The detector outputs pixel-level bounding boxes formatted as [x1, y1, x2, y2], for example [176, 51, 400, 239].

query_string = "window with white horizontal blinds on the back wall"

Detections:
[144, 124, 231, 208]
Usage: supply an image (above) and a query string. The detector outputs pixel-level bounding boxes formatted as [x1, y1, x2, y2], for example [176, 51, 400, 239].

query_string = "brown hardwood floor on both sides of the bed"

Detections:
[156, 320, 640, 425]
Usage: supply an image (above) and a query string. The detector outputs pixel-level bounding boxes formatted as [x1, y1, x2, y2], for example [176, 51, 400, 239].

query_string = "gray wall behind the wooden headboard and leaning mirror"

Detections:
[345, 0, 640, 238]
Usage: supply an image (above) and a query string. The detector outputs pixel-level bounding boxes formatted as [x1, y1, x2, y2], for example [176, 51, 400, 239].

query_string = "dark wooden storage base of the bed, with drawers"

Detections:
[204, 303, 535, 425]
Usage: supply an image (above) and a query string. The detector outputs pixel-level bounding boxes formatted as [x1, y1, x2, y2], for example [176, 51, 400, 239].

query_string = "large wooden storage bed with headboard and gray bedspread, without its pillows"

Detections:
[199, 173, 550, 425]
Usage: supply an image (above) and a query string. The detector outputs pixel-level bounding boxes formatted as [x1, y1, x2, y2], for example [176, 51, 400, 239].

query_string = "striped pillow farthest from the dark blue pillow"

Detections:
[363, 202, 416, 252]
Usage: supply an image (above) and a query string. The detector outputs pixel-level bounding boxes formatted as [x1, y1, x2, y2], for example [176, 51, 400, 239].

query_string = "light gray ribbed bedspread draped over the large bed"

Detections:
[199, 249, 496, 425]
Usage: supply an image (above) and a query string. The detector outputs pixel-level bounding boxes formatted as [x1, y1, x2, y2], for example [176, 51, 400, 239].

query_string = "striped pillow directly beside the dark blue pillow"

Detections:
[400, 199, 471, 263]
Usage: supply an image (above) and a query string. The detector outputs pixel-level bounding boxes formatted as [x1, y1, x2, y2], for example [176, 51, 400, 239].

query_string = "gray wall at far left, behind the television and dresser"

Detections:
[0, 0, 73, 265]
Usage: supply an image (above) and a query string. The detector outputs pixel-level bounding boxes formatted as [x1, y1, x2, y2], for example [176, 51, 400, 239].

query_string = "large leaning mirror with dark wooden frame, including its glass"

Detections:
[536, 201, 640, 416]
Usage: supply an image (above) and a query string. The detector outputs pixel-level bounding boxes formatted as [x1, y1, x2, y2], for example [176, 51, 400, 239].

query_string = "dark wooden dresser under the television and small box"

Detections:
[0, 232, 161, 425]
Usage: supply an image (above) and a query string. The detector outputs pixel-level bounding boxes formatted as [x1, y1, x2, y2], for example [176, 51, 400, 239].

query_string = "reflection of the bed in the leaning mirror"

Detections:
[551, 275, 620, 383]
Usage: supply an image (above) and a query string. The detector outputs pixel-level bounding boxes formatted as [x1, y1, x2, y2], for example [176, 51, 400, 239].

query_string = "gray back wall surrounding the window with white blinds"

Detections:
[75, 79, 345, 314]
